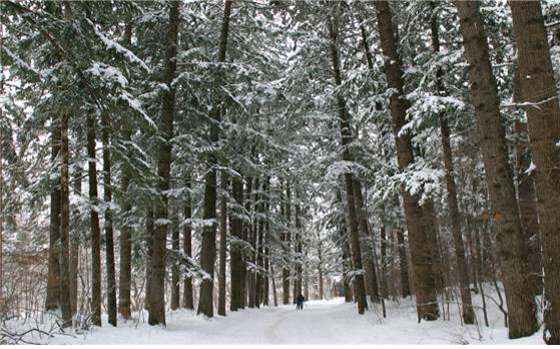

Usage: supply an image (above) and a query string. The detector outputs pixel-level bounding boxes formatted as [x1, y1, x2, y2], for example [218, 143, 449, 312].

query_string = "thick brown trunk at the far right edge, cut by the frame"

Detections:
[508, 1, 560, 345]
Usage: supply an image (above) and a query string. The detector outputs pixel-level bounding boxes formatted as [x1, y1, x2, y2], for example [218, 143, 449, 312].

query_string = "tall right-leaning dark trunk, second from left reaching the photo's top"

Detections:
[198, 0, 232, 317]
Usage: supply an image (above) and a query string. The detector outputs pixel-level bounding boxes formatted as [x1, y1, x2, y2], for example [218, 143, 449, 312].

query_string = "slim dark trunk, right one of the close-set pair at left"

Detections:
[101, 112, 117, 326]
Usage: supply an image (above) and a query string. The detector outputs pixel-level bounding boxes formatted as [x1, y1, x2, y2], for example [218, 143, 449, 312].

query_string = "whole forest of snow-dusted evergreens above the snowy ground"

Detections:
[0, 0, 560, 344]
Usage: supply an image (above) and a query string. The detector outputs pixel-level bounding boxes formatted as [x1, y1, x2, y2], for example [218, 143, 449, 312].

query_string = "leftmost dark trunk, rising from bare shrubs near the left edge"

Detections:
[45, 118, 61, 311]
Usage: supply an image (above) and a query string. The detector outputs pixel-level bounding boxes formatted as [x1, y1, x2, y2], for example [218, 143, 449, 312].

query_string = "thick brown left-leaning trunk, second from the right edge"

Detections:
[456, 1, 538, 338]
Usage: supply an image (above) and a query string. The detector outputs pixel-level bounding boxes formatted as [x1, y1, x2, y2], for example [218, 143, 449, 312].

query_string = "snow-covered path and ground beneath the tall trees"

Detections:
[2, 286, 543, 344]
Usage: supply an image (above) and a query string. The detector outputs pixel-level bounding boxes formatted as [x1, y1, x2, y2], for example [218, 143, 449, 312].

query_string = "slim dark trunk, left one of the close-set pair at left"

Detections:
[87, 113, 101, 326]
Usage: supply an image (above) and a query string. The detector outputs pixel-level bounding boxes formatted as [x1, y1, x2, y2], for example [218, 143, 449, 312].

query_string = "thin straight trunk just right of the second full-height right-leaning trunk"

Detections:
[218, 171, 228, 316]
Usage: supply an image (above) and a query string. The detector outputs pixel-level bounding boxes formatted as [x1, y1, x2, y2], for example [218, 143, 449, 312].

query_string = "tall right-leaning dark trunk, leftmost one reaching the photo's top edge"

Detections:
[148, 1, 180, 326]
